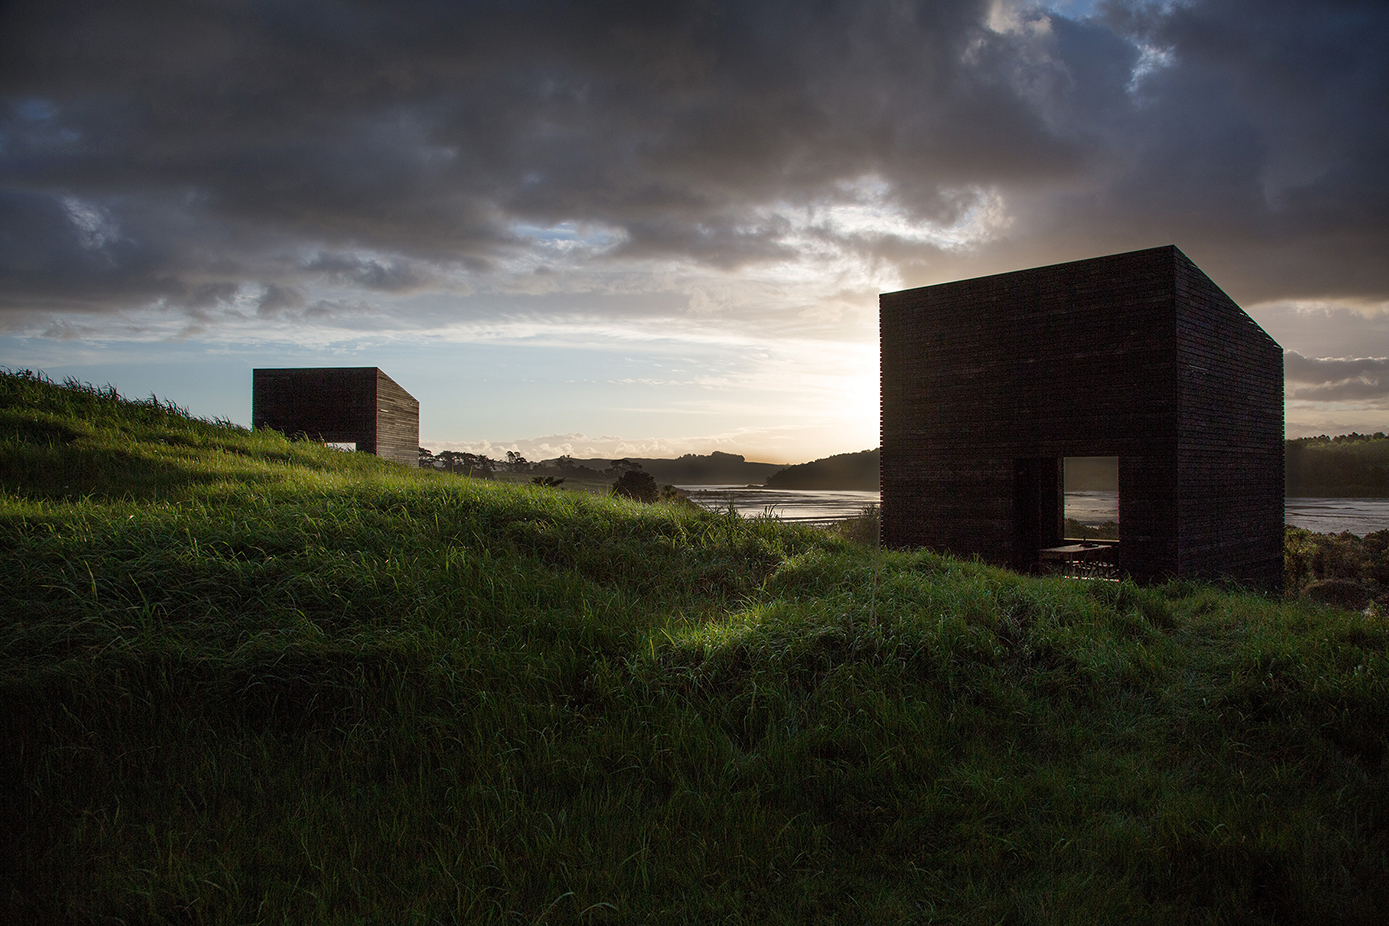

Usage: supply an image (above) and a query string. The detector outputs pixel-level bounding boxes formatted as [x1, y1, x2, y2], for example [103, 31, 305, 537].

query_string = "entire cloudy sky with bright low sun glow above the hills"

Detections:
[0, 0, 1389, 462]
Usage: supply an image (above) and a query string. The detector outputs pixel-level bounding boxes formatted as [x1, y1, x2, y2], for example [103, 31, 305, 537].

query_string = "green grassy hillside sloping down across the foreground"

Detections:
[0, 373, 1389, 923]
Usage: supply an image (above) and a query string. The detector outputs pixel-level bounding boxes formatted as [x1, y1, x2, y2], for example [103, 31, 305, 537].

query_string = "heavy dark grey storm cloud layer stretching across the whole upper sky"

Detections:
[0, 0, 1389, 315]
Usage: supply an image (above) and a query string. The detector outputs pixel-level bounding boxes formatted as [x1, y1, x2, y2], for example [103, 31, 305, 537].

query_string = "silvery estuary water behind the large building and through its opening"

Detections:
[681, 486, 1389, 536]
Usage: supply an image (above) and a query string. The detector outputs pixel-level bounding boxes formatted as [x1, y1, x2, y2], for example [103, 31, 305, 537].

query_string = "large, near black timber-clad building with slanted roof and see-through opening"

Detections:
[879, 247, 1283, 587]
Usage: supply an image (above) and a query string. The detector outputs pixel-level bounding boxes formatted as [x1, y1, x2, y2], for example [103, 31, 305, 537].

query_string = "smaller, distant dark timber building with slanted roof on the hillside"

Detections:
[251, 367, 419, 466]
